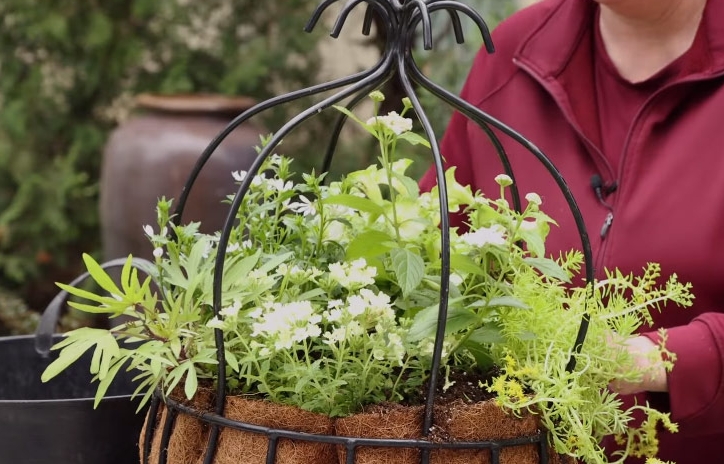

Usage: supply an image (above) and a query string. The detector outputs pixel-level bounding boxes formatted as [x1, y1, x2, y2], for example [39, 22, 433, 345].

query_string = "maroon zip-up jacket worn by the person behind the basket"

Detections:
[421, 0, 724, 464]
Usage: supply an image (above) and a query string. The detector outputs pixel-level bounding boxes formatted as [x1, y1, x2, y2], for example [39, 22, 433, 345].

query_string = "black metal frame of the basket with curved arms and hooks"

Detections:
[142, 0, 594, 464]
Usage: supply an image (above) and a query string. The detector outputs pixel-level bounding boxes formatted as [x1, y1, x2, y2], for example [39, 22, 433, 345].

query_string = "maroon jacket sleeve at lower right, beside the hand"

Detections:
[644, 313, 724, 434]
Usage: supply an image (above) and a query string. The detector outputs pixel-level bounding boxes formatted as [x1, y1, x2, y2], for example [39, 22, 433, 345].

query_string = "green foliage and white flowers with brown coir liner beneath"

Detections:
[43, 92, 692, 463]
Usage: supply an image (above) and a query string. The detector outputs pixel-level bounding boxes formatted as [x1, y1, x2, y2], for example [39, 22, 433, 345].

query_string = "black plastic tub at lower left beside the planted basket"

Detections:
[0, 335, 145, 464]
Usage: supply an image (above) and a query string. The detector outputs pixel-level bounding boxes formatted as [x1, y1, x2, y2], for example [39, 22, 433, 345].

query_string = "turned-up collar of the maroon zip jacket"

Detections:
[515, 0, 724, 79]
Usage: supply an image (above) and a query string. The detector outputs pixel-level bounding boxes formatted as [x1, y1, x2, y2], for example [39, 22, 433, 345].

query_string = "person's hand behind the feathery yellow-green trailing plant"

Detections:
[611, 336, 669, 395]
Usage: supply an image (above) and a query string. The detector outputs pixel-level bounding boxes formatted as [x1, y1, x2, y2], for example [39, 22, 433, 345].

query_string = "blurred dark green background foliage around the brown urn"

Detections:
[0, 0, 514, 334]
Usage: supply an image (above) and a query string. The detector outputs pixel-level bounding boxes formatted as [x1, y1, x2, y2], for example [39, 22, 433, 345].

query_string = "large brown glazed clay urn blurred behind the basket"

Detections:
[100, 95, 264, 260]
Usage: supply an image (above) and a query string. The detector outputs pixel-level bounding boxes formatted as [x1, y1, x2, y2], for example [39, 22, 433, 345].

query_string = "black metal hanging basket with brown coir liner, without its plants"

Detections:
[134, 0, 593, 464]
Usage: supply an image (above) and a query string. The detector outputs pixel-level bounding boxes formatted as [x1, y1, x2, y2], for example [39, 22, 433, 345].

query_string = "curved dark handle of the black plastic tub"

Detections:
[35, 258, 155, 358]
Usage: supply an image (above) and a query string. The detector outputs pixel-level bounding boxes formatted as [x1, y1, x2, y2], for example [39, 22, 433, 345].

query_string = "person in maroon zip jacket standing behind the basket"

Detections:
[421, 0, 724, 464]
